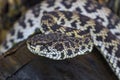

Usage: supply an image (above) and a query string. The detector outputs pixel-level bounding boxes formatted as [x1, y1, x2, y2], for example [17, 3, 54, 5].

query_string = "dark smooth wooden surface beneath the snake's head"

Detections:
[0, 43, 118, 80]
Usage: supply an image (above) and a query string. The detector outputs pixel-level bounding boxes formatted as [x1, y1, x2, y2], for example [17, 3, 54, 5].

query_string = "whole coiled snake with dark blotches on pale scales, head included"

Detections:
[0, 0, 120, 80]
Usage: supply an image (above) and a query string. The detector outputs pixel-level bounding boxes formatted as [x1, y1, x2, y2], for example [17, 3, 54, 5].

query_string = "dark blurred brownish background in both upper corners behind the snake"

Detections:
[0, 0, 120, 43]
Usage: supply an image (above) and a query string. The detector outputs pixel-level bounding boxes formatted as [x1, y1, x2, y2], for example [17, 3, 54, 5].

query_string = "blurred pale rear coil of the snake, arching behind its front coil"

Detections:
[0, 0, 120, 53]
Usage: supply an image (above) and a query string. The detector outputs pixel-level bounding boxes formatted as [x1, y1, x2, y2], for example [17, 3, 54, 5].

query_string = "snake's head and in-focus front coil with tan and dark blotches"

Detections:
[26, 11, 120, 79]
